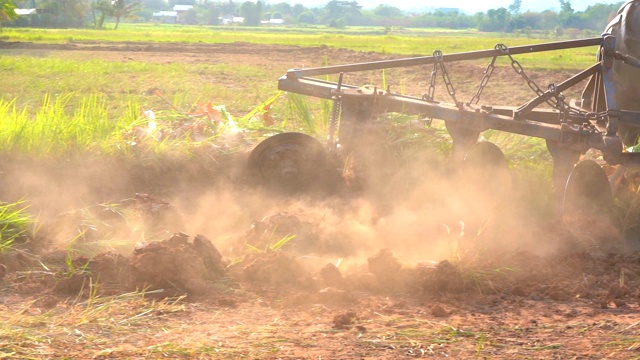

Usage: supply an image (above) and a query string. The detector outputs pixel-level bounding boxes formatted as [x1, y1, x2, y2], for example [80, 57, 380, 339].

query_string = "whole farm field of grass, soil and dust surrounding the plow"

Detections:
[0, 25, 640, 359]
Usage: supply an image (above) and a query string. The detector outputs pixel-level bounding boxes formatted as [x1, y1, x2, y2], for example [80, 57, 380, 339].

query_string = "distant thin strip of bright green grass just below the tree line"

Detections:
[2, 24, 597, 69]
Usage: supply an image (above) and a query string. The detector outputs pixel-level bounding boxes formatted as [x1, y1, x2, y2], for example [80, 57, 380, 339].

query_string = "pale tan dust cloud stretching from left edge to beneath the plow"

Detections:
[3, 132, 568, 272]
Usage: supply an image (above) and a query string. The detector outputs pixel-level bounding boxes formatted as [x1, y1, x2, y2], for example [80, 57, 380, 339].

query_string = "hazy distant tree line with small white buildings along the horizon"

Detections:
[0, 0, 622, 35]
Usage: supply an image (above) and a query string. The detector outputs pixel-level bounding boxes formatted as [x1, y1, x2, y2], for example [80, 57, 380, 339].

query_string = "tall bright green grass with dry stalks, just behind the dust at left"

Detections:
[0, 92, 326, 158]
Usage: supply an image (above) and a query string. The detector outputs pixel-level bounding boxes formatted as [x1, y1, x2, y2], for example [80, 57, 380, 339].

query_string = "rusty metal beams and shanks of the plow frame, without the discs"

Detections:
[278, 34, 640, 167]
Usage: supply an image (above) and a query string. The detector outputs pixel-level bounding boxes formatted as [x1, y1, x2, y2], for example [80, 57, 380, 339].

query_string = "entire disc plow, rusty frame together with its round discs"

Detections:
[250, 28, 640, 218]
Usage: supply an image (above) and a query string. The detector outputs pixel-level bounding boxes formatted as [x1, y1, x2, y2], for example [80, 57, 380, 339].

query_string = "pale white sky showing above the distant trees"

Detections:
[292, 0, 621, 14]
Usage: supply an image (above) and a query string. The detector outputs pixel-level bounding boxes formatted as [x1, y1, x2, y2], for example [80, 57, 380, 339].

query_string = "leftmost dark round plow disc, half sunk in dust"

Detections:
[248, 133, 327, 192]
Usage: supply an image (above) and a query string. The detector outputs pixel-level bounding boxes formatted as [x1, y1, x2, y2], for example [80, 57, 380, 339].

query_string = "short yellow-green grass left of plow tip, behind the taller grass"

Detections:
[0, 55, 275, 113]
